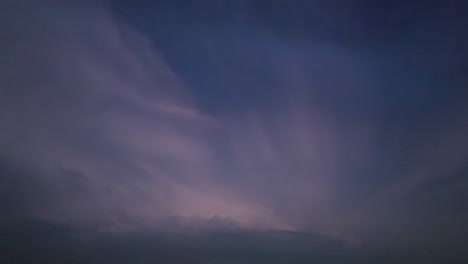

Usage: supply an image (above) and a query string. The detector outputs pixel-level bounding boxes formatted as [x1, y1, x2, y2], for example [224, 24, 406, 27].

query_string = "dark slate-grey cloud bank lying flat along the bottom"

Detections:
[0, 219, 462, 264]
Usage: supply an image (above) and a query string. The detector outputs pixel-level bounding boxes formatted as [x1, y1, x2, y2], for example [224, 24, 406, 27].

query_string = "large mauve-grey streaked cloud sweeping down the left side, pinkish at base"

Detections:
[0, 2, 298, 231]
